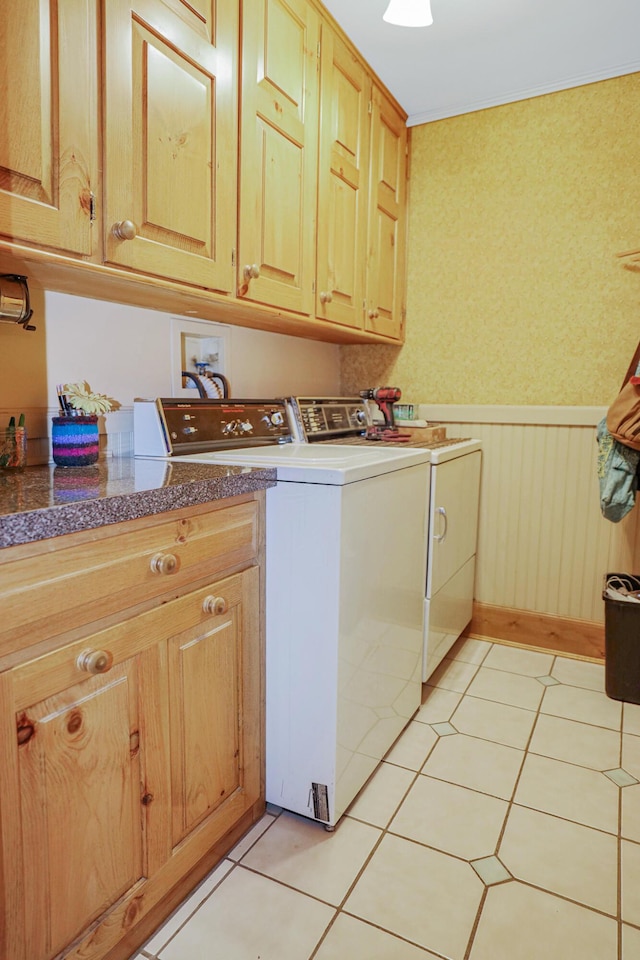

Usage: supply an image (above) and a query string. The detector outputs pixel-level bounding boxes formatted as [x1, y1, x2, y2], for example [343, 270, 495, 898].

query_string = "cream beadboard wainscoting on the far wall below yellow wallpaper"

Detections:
[420, 407, 640, 621]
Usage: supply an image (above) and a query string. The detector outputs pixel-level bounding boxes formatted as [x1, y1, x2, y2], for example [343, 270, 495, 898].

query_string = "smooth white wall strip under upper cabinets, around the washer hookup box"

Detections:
[45, 292, 340, 408]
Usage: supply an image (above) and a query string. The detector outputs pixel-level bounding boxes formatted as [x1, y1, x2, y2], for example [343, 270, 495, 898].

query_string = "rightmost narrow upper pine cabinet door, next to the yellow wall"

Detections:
[365, 87, 407, 339]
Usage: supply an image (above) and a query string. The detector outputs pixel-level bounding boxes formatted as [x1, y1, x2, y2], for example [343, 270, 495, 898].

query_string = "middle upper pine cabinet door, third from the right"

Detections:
[238, 0, 320, 314]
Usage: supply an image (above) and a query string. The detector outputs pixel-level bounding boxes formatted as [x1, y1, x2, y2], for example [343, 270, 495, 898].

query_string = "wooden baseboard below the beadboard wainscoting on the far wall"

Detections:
[464, 602, 604, 661]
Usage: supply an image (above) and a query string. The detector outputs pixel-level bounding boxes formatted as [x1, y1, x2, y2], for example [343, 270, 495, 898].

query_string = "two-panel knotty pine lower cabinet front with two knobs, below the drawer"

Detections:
[0, 502, 264, 960]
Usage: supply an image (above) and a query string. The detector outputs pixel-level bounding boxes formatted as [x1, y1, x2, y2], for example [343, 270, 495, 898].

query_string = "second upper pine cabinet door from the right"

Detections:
[316, 26, 371, 327]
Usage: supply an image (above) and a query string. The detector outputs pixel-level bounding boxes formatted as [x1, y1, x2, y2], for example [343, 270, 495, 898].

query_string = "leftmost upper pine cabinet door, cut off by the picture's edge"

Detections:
[0, 0, 98, 255]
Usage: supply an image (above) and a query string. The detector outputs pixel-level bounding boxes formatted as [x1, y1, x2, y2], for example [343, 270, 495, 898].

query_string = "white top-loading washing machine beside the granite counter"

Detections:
[134, 399, 431, 828]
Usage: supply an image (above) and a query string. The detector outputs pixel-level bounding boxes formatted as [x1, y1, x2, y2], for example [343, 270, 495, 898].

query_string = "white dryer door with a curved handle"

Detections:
[427, 450, 482, 597]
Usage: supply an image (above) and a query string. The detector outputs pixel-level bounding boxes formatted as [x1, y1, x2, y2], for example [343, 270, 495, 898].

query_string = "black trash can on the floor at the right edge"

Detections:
[602, 573, 640, 703]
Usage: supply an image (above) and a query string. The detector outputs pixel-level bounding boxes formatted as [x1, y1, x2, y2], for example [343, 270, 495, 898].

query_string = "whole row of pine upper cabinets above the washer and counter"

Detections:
[0, 0, 407, 342]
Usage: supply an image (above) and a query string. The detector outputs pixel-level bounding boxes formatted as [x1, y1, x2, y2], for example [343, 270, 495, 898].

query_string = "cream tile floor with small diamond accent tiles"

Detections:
[132, 640, 640, 960]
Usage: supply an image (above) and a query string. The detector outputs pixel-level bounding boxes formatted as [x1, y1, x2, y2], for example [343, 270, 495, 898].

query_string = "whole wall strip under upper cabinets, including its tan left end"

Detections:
[0, 290, 340, 464]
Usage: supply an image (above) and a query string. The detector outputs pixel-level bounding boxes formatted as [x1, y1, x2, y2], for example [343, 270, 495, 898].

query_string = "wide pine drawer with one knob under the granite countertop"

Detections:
[0, 501, 258, 657]
